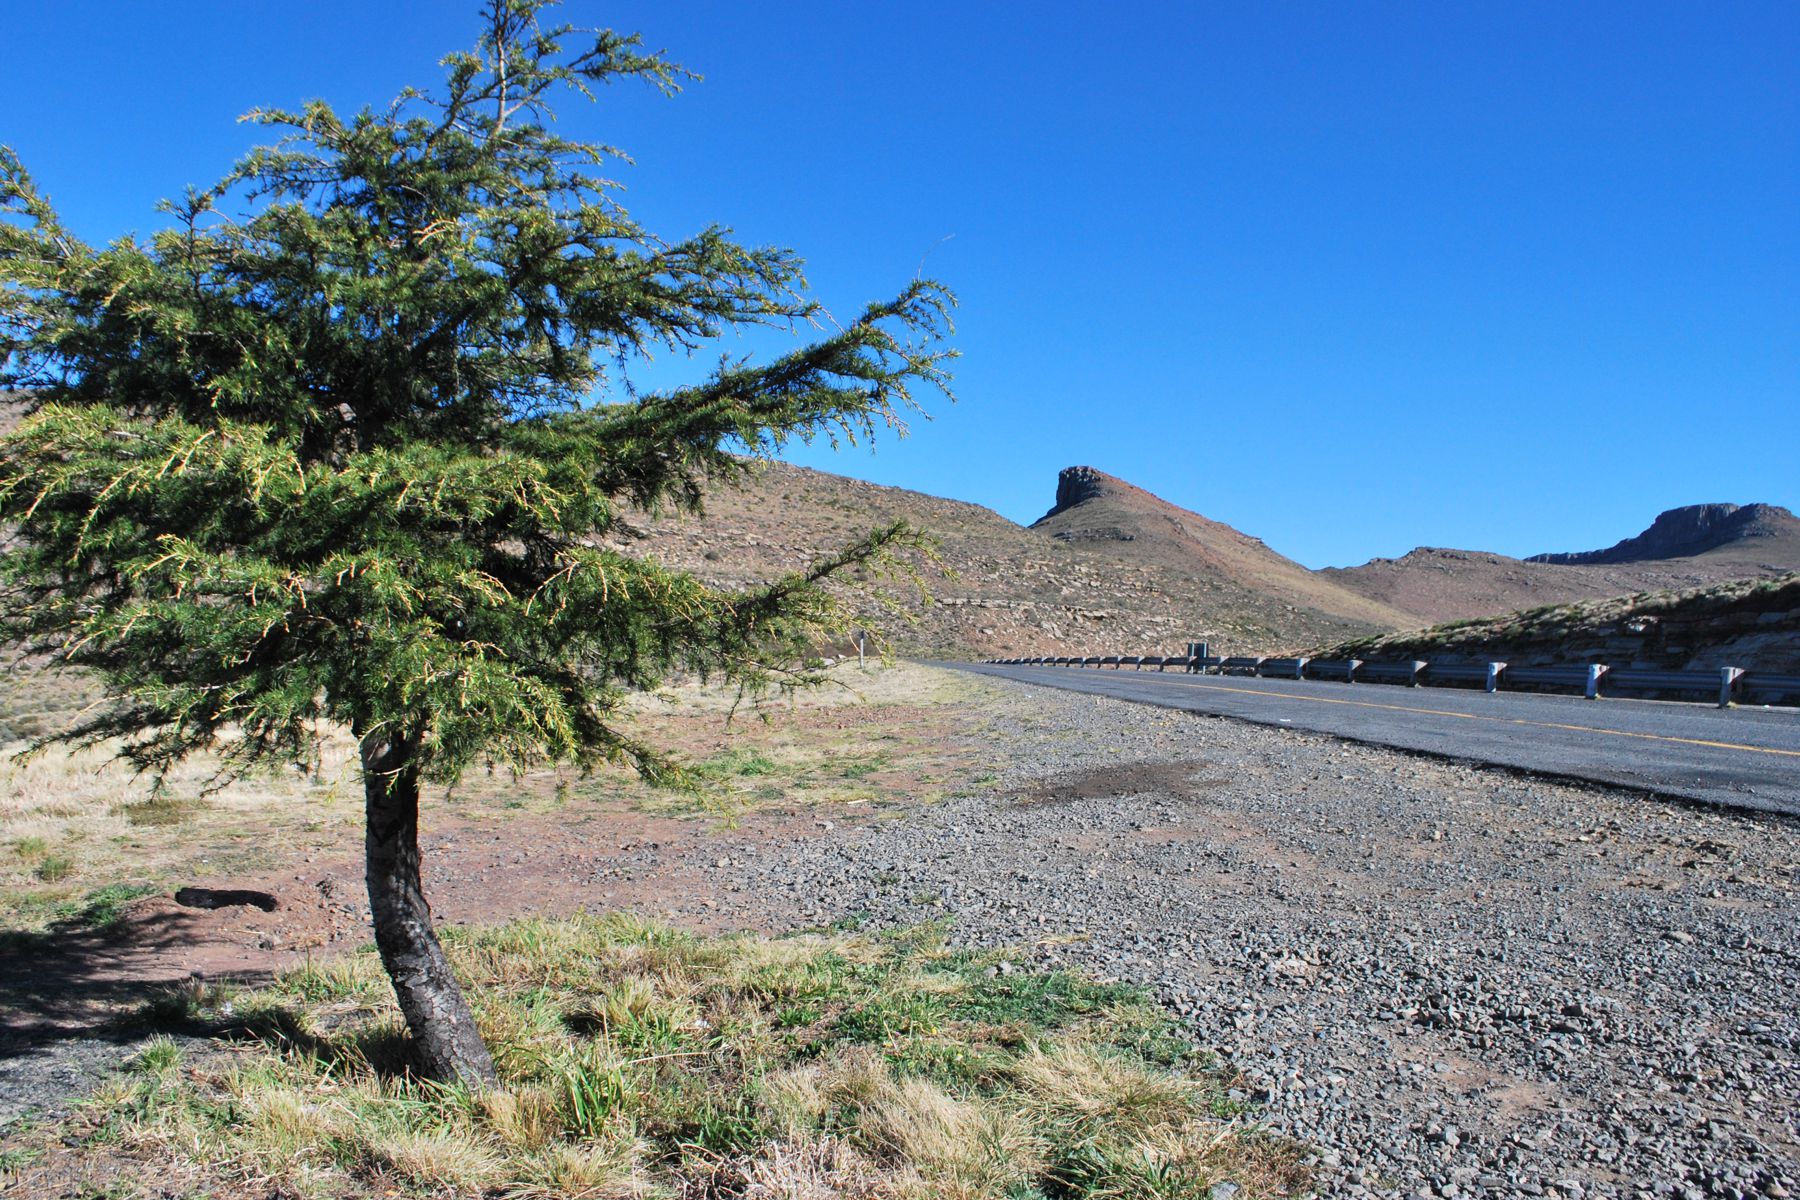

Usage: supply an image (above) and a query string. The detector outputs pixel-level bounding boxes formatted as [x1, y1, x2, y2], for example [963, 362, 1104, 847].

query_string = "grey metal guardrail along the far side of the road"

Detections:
[985, 655, 1800, 707]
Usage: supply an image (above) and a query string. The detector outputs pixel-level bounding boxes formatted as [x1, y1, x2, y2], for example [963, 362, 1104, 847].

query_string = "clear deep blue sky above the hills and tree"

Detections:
[0, 0, 1800, 567]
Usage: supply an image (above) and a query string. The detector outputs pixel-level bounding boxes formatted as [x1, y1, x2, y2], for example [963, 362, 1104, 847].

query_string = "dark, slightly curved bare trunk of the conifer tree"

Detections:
[362, 734, 497, 1088]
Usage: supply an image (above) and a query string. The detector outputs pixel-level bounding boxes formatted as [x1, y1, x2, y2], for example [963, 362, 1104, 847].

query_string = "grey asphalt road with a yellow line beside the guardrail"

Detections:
[940, 662, 1800, 815]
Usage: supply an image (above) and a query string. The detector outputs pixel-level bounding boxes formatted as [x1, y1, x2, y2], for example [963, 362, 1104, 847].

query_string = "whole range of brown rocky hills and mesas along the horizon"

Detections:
[0, 385, 1800, 657]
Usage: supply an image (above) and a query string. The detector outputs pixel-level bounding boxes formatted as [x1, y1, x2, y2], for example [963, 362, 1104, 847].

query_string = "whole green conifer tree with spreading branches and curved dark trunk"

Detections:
[0, 0, 950, 1085]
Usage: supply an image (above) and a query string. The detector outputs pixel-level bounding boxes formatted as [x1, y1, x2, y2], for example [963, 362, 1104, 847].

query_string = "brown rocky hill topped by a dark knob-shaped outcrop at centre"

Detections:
[635, 462, 1418, 657]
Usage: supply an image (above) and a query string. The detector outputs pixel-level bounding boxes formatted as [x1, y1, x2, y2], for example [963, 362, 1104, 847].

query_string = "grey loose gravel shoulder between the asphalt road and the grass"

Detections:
[687, 684, 1800, 1200]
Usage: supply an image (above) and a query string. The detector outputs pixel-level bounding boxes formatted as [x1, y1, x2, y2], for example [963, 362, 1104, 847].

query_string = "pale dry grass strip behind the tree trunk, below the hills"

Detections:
[0, 662, 1015, 930]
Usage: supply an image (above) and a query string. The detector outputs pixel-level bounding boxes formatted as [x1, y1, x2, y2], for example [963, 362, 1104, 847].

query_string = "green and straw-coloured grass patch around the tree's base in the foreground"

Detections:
[24, 916, 1305, 1200]
